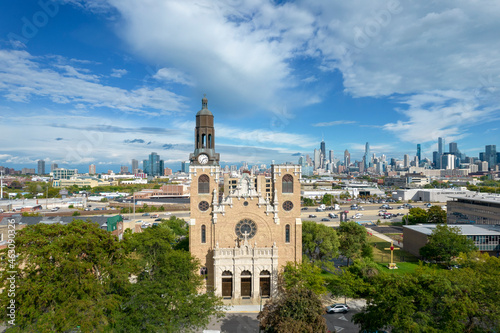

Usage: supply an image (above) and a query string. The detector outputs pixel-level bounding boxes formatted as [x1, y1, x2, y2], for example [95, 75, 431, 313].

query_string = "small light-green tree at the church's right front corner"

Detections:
[280, 261, 327, 295]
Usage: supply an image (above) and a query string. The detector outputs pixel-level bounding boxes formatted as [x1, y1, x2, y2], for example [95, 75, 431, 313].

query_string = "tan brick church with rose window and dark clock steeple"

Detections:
[189, 98, 302, 302]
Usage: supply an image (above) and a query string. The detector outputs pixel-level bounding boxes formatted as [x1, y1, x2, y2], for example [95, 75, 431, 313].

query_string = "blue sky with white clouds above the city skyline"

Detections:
[0, 0, 500, 171]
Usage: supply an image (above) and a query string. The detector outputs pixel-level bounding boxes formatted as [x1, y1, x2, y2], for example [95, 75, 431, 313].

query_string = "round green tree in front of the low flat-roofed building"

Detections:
[419, 224, 476, 265]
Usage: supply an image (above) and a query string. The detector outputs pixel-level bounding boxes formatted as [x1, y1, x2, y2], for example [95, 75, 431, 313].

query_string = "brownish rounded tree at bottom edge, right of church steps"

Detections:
[257, 287, 327, 333]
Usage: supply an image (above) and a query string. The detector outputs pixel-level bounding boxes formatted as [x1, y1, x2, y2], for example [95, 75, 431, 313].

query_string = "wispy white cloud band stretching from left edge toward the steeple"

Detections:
[0, 50, 185, 115]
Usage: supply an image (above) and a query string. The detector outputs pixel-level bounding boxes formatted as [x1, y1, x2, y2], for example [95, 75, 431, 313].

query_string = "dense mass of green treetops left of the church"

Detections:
[0, 218, 223, 332]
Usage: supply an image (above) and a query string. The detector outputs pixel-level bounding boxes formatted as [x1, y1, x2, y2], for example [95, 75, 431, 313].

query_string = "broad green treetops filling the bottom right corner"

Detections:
[353, 258, 500, 333]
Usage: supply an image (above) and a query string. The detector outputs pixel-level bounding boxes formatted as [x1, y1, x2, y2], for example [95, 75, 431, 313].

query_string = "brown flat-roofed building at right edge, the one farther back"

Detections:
[446, 194, 500, 225]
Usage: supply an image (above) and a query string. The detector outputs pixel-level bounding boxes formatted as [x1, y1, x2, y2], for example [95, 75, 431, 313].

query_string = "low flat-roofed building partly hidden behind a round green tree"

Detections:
[403, 224, 500, 256]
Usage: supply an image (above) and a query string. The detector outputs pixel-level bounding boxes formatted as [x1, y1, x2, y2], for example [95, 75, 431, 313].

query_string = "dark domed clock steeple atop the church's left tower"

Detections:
[189, 96, 219, 165]
